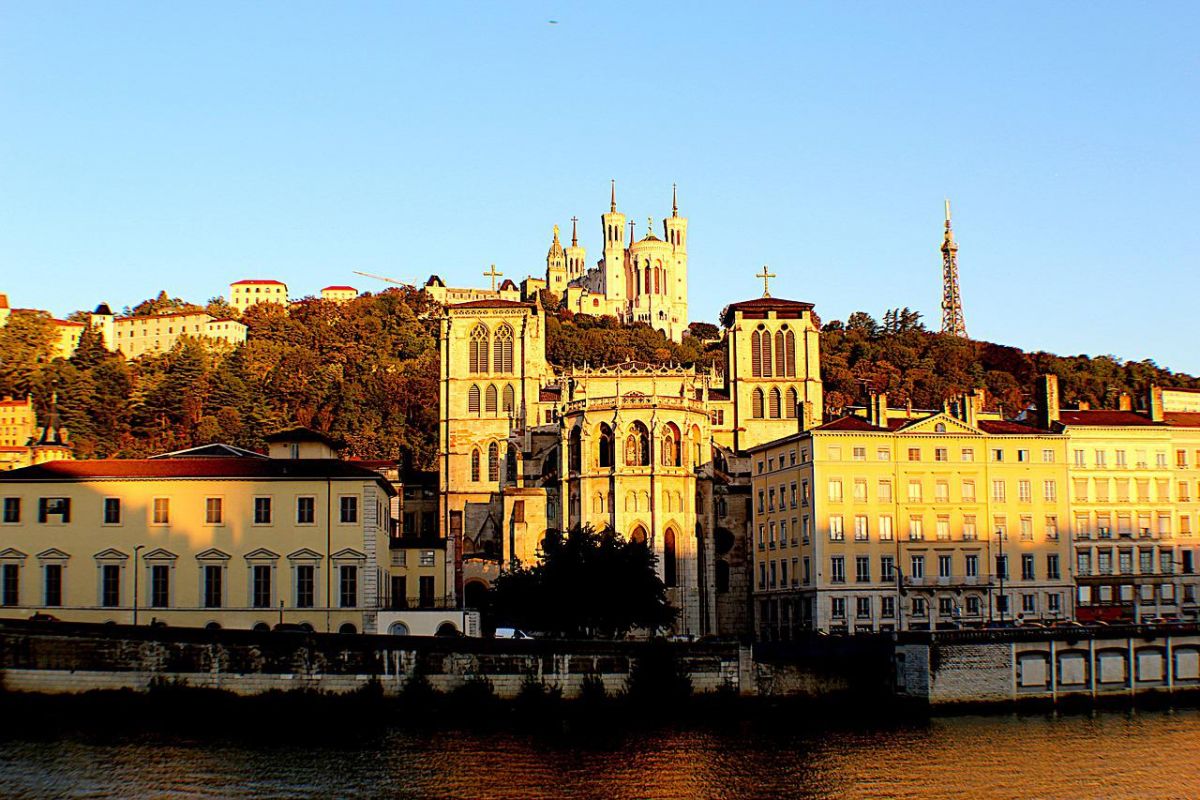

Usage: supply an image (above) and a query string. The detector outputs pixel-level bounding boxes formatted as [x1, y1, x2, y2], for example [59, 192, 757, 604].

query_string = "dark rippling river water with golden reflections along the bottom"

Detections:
[0, 709, 1200, 800]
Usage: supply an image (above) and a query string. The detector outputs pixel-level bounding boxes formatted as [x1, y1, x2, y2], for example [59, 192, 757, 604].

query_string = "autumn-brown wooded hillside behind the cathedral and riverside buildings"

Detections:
[0, 289, 1200, 467]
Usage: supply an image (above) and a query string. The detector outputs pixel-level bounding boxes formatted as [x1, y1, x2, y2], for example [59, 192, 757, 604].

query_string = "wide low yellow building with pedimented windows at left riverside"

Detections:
[0, 434, 394, 632]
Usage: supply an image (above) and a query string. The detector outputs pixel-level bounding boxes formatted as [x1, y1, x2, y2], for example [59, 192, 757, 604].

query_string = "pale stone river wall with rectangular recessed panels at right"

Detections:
[895, 625, 1200, 705]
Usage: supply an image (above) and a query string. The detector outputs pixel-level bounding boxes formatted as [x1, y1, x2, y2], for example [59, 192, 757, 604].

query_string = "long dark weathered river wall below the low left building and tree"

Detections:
[0, 622, 754, 698]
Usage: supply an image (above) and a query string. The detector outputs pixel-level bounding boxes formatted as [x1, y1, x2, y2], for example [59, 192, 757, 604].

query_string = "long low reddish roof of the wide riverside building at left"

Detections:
[0, 457, 395, 494]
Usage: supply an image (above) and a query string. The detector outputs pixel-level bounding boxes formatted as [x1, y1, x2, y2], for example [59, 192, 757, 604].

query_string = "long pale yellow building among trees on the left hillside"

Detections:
[89, 303, 247, 359]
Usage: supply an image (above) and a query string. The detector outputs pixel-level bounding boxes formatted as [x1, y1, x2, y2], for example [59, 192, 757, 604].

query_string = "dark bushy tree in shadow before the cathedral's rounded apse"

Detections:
[490, 525, 678, 638]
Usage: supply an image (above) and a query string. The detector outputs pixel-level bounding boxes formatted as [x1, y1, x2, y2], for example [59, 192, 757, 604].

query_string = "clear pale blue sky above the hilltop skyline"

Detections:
[0, 0, 1200, 373]
